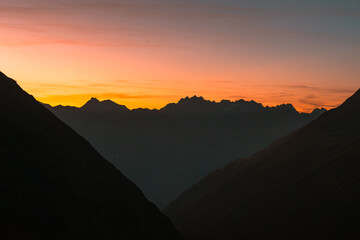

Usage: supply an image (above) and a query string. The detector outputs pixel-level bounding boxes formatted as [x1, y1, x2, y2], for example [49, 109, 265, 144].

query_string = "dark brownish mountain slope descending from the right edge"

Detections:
[164, 90, 360, 240]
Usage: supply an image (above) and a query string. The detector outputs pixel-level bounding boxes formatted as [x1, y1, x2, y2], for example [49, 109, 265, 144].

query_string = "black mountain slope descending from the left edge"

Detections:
[0, 73, 182, 240]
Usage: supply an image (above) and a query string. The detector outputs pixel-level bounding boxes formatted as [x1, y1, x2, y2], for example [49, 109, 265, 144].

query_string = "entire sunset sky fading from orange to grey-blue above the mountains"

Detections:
[0, 0, 360, 112]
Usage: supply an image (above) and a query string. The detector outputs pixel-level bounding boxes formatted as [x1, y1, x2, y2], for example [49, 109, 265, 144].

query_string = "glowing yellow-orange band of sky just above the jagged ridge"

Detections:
[14, 77, 356, 112]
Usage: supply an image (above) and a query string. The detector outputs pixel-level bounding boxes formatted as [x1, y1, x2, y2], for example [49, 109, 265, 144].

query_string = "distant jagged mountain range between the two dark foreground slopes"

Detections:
[45, 96, 323, 208]
